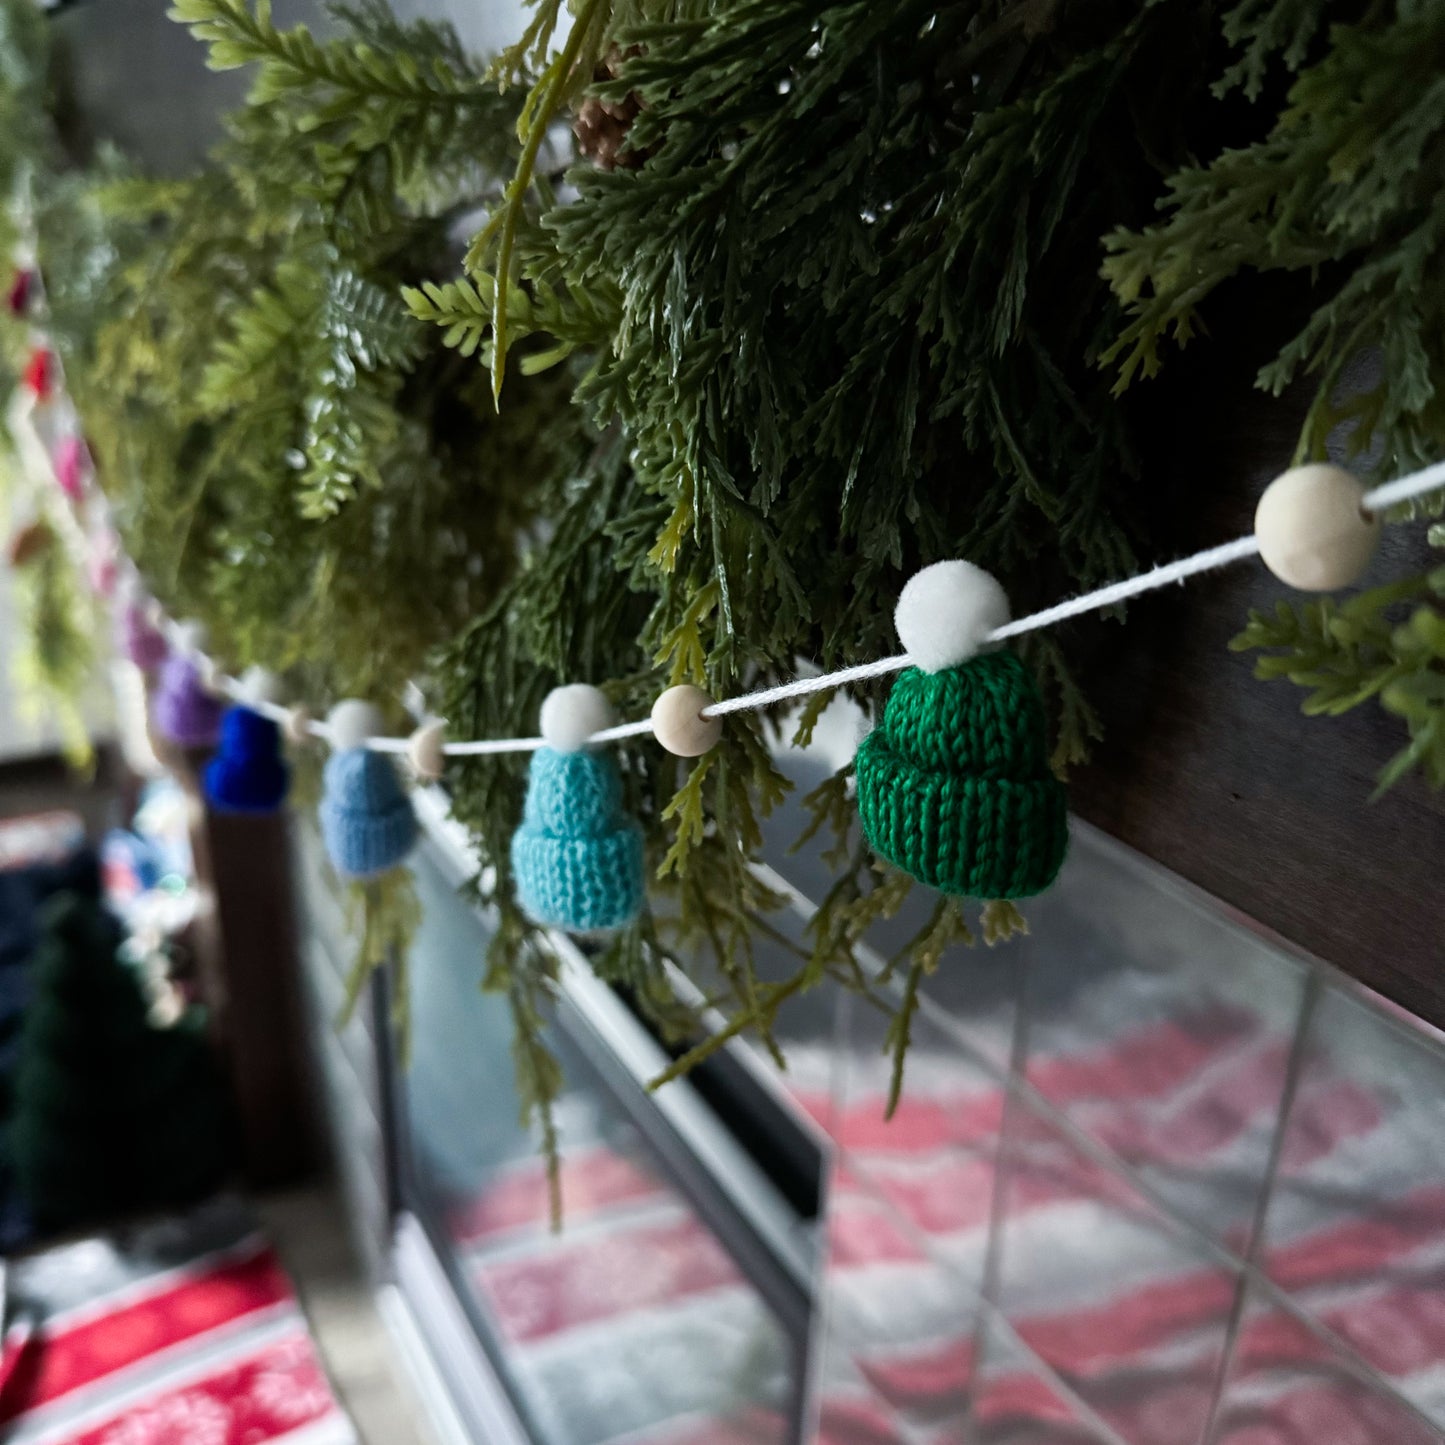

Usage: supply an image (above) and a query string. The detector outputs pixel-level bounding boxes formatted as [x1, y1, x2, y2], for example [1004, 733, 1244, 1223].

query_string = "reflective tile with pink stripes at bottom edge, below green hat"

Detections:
[998, 1108, 1235, 1445]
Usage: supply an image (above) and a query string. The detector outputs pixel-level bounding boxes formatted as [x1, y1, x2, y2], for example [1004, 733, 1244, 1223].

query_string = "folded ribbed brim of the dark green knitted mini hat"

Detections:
[857, 730, 1069, 899]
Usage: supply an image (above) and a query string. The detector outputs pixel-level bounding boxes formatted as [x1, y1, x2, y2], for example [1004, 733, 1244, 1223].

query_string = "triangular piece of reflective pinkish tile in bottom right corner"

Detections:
[1212, 1287, 1439, 1445]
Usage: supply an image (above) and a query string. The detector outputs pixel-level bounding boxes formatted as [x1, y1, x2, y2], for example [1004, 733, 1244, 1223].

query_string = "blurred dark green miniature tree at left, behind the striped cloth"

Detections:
[10, 894, 228, 1230]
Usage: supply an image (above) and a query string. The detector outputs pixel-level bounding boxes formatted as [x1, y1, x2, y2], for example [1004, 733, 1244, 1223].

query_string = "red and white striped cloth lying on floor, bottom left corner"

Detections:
[0, 1202, 355, 1445]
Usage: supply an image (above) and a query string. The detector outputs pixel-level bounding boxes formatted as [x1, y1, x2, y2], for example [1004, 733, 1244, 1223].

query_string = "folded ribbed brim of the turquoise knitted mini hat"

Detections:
[512, 827, 643, 933]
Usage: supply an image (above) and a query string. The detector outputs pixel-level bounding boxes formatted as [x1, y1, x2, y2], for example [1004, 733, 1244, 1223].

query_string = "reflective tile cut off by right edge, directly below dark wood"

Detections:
[1263, 988, 1445, 1428]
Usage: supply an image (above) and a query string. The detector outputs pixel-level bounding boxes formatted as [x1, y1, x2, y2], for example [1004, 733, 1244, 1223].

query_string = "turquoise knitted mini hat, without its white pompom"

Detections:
[512, 747, 643, 933]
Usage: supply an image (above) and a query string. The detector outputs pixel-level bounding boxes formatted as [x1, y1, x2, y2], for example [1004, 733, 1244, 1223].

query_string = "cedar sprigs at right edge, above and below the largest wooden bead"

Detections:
[1104, 0, 1445, 790]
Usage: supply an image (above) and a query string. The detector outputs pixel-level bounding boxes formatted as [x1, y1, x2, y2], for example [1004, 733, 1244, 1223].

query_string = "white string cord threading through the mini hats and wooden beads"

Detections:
[143, 461, 1445, 757]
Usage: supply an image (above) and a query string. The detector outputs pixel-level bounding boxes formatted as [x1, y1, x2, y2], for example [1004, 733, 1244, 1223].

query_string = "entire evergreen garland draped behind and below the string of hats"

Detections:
[0, 0, 1445, 1167]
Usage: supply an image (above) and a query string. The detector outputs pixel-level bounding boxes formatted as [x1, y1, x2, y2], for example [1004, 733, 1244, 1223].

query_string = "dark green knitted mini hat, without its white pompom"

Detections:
[857, 652, 1069, 899]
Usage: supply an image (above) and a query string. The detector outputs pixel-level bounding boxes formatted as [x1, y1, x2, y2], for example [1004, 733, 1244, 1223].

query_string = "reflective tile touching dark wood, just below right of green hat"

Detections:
[1023, 824, 1306, 1251]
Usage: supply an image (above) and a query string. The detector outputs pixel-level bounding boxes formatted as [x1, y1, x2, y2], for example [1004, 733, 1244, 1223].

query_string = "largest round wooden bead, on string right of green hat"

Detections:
[1254, 462, 1380, 592]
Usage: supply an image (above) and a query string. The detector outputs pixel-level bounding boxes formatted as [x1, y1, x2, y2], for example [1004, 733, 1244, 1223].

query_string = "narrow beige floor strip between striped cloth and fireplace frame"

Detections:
[257, 1186, 438, 1445]
